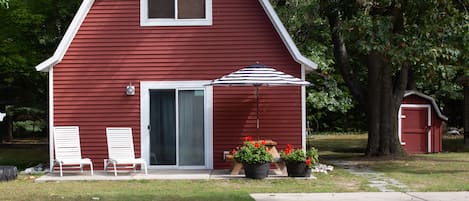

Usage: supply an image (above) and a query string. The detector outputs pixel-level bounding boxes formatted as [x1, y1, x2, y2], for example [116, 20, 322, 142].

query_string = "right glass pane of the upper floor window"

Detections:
[178, 0, 205, 19]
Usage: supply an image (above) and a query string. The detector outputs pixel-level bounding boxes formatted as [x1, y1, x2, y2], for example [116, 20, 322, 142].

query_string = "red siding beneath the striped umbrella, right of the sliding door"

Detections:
[213, 86, 301, 169]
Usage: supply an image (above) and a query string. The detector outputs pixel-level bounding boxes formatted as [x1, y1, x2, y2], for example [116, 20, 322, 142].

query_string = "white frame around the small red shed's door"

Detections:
[397, 104, 432, 153]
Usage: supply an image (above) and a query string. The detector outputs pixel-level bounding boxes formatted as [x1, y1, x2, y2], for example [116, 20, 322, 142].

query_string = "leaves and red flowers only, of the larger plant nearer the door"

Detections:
[234, 140, 273, 165]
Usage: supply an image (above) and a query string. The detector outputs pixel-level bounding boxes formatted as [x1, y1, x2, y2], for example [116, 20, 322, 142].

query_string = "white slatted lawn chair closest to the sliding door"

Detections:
[104, 128, 148, 176]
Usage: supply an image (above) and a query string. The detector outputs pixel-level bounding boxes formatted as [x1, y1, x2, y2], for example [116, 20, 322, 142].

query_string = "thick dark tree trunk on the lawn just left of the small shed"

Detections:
[365, 52, 408, 156]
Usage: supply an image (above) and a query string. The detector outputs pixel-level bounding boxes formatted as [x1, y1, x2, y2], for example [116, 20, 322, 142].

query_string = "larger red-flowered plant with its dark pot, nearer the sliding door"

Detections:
[234, 140, 273, 179]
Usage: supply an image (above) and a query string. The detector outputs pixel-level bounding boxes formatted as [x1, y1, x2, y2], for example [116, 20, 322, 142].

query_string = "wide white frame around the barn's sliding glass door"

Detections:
[140, 80, 213, 169]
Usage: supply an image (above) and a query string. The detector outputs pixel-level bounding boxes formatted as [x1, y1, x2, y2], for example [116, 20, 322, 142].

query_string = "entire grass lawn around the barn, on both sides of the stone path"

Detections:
[0, 134, 469, 201]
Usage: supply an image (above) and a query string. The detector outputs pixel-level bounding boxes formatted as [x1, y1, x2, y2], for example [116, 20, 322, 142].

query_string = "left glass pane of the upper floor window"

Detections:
[148, 0, 175, 19]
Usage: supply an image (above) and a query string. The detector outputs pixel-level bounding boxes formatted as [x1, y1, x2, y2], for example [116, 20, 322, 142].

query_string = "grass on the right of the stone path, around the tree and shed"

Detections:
[308, 134, 469, 191]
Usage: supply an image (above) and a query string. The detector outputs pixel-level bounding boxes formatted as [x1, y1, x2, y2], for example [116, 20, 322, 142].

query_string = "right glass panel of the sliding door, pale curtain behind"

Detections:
[178, 90, 205, 166]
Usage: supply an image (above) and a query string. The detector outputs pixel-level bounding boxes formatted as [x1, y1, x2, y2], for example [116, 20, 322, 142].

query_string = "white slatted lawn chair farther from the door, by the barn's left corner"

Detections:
[54, 126, 93, 177]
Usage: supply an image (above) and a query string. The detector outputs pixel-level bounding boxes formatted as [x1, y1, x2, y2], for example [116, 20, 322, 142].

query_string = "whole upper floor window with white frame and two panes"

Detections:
[140, 0, 212, 26]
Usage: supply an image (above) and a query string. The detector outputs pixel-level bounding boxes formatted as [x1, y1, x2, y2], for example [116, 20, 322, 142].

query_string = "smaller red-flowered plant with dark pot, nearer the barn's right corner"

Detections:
[280, 144, 319, 177]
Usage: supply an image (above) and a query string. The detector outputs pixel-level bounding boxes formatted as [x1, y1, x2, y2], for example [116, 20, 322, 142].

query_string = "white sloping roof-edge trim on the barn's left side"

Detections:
[36, 0, 94, 72]
